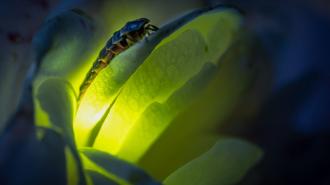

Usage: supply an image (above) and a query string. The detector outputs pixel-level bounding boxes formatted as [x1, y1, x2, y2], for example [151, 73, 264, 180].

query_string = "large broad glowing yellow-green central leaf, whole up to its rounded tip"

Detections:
[94, 9, 241, 160]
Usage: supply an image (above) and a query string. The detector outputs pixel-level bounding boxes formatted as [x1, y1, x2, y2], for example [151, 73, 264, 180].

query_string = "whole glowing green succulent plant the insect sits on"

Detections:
[3, 1, 268, 185]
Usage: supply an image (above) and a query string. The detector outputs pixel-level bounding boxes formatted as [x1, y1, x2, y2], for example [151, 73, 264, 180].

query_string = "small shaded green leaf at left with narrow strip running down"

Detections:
[34, 78, 85, 185]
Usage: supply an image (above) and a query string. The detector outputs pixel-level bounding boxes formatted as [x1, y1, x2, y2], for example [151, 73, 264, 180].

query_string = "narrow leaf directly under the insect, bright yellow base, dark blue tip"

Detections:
[74, 6, 224, 146]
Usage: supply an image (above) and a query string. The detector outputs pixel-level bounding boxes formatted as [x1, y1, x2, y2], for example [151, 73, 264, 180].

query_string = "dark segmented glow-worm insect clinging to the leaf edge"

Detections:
[78, 18, 158, 101]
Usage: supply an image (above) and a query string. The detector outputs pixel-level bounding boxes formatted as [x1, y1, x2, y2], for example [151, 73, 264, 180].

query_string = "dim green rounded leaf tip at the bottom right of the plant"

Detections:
[164, 139, 262, 185]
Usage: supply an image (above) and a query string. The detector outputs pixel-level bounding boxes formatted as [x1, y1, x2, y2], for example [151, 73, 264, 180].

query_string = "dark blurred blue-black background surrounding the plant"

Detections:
[0, 0, 330, 185]
